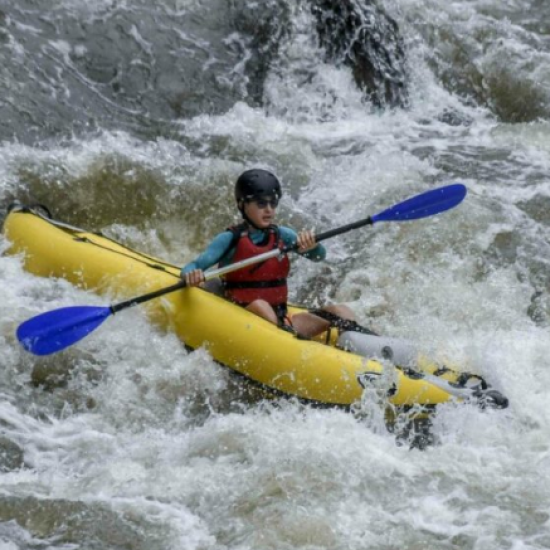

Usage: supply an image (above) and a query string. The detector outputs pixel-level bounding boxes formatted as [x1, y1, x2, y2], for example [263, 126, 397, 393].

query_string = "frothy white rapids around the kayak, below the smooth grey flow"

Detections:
[0, 0, 550, 550]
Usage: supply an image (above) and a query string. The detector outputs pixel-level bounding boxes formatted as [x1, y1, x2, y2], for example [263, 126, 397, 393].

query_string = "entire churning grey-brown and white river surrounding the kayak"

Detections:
[0, 0, 550, 550]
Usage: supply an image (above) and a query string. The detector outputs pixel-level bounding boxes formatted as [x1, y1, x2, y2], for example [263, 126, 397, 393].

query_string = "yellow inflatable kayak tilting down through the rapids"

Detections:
[3, 206, 507, 410]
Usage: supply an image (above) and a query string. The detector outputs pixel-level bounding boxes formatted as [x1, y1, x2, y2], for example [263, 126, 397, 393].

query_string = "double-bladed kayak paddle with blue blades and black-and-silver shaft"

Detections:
[17, 183, 466, 355]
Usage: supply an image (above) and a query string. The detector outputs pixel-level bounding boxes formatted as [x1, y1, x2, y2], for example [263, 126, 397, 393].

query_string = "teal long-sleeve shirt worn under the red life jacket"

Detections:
[181, 226, 327, 275]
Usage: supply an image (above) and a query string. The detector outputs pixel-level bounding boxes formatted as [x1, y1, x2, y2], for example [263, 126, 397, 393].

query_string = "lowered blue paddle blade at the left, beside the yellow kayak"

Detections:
[17, 306, 112, 355]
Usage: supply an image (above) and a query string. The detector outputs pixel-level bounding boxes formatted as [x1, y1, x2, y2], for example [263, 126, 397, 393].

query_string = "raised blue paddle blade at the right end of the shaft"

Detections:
[371, 183, 466, 223]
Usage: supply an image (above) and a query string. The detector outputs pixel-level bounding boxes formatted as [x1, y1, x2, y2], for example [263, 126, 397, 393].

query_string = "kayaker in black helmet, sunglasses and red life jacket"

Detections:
[181, 168, 354, 338]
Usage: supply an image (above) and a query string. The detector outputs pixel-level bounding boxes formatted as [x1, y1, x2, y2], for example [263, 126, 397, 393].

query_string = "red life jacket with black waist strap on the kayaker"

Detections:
[224, 224, 290, 306]
